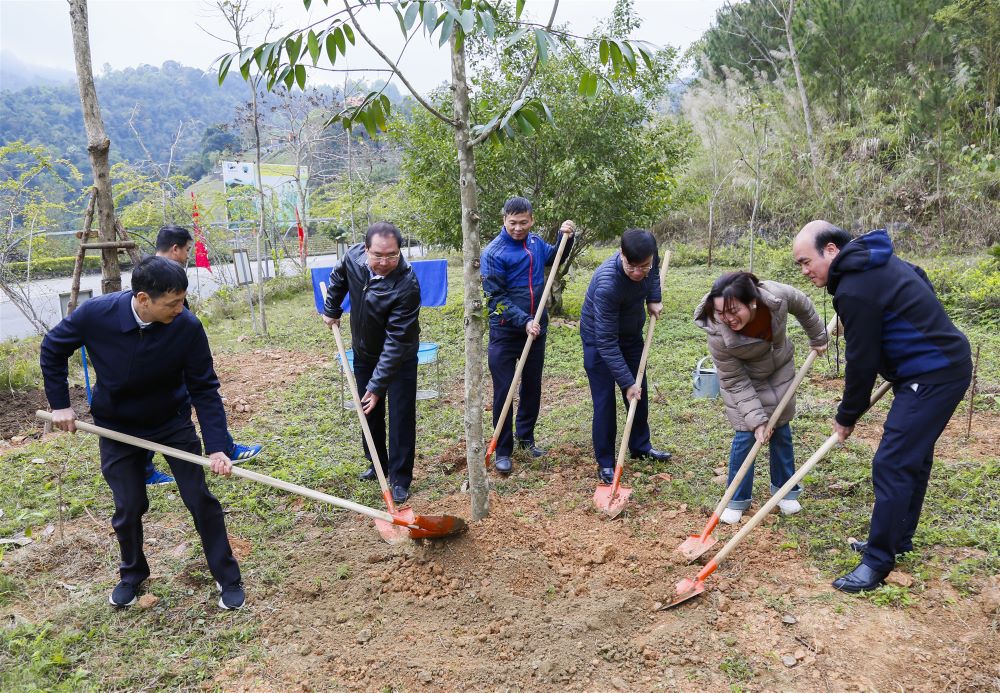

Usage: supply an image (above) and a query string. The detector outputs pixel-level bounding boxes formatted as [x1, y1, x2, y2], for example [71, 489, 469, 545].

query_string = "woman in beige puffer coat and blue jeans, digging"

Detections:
[694, 272, 827, 524]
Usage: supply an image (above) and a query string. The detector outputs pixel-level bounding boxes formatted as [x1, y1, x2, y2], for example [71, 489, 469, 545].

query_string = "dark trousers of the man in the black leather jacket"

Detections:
[354, 356, 417, 489]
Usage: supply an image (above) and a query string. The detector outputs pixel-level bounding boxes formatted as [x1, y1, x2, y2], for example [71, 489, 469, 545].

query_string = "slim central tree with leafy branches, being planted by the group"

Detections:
[218, 0, 655, 520]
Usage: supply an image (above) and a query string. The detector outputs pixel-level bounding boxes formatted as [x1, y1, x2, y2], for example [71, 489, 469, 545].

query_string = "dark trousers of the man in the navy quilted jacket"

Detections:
[583, 337, 653, 468]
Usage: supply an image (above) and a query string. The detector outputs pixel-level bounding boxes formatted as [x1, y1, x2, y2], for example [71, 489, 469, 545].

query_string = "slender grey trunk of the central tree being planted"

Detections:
[451, 36, 490, 520]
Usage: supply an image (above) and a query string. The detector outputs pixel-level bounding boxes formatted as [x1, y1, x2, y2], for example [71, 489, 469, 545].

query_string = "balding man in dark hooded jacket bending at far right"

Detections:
[792, 221, 972, 592]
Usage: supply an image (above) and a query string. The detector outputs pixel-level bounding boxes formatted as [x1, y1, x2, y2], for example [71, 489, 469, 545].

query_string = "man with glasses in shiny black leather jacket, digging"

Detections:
[323, 221, 420, 503]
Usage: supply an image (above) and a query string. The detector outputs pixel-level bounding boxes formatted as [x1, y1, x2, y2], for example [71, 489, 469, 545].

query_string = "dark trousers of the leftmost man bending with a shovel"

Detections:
[100, 414, 241, 586]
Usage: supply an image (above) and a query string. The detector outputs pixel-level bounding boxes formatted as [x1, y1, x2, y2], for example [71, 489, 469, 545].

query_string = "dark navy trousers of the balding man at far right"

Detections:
[861, 375, 971, 572]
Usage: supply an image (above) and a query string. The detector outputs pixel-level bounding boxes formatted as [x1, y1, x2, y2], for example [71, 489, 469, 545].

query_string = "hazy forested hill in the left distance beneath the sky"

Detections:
[0, 61, 248, 176]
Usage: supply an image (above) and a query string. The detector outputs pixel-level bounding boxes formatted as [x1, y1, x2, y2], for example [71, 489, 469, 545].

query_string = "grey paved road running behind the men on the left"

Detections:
[0, 247, 423, 341]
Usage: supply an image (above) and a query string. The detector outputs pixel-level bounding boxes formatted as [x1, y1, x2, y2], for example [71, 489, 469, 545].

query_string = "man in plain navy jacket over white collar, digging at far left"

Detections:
[41, 256, 245, 609]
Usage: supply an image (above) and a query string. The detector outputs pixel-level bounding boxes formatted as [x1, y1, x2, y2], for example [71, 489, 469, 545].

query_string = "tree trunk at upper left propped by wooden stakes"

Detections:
[69, 0, 122, 294]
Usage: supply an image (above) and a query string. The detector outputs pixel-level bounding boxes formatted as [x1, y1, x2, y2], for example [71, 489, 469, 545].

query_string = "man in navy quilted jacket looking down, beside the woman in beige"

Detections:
[580, 229, 670, 484]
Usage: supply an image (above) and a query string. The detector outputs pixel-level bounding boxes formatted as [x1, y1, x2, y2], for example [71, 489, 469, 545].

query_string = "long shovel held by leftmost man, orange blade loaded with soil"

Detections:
[35, 409, 467, 539]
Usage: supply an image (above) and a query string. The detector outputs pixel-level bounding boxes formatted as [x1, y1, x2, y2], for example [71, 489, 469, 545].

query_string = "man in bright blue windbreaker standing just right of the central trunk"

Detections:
[480, 197, 576, 475]
